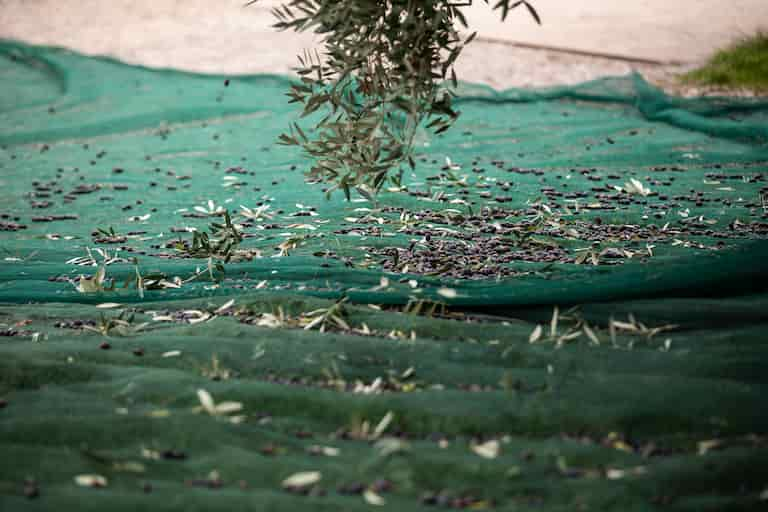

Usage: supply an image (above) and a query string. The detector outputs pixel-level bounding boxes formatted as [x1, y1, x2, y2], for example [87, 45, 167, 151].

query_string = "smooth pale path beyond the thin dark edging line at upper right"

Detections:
[460, 0, 768, 63]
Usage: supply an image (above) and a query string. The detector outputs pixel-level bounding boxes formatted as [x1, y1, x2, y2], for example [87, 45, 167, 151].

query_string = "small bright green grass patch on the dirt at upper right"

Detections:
[683, 32, 768, 92]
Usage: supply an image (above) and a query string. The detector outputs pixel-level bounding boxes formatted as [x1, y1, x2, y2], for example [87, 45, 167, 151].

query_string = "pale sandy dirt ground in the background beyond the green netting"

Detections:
[0, 0, 768, 95]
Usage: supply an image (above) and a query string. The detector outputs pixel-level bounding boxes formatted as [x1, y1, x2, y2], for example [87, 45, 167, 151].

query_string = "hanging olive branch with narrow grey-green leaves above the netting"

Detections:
[249, 0, 540, 198]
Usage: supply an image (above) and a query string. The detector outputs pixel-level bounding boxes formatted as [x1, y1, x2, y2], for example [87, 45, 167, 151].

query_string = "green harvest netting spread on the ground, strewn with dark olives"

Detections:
[0, 42, 768, 510]
